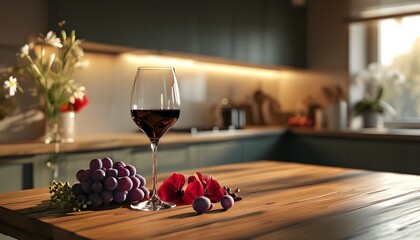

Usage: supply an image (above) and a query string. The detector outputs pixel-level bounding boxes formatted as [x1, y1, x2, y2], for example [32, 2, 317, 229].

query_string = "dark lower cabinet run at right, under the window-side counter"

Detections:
[284, 132, 420, 174]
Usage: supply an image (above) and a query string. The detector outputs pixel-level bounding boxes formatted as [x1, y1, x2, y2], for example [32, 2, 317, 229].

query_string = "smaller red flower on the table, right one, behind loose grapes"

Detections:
[188, 172, 226, 203]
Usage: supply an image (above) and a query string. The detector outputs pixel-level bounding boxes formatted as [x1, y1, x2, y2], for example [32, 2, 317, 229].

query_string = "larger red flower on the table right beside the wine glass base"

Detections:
[158, 173, 204, 205]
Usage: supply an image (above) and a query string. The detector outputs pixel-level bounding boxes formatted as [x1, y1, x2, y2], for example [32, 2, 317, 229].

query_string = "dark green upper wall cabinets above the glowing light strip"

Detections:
[50, 0, 306, 67]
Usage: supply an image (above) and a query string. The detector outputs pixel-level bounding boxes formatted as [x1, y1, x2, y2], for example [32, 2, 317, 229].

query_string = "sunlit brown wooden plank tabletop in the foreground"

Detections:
[0, 161, 420, 239]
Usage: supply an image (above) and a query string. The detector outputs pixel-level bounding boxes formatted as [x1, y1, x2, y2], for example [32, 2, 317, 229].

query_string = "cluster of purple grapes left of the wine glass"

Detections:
[72, 157, 149, 208]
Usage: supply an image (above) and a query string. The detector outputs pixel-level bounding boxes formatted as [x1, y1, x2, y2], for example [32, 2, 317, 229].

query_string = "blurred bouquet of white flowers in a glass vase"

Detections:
[1, 31, 88, 143]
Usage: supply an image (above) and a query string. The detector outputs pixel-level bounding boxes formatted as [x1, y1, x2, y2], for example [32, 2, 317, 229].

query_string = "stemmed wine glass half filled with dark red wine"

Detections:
[130, 67, 180, 211]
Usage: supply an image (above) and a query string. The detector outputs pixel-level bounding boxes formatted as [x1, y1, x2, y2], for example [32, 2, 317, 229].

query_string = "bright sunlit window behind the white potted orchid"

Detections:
[376, 15, 420, 121]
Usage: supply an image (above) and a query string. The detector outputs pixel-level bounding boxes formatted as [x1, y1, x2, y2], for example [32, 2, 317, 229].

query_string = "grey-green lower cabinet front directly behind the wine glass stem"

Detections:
[130, 135, 281, 173]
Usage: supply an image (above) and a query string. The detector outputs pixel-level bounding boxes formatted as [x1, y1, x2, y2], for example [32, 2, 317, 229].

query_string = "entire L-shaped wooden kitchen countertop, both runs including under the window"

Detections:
[0, 126, 420, 157]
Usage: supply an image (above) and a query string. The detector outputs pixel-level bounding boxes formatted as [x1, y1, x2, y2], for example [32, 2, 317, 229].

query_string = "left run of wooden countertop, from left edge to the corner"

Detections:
[0, 127, 286, 157]
